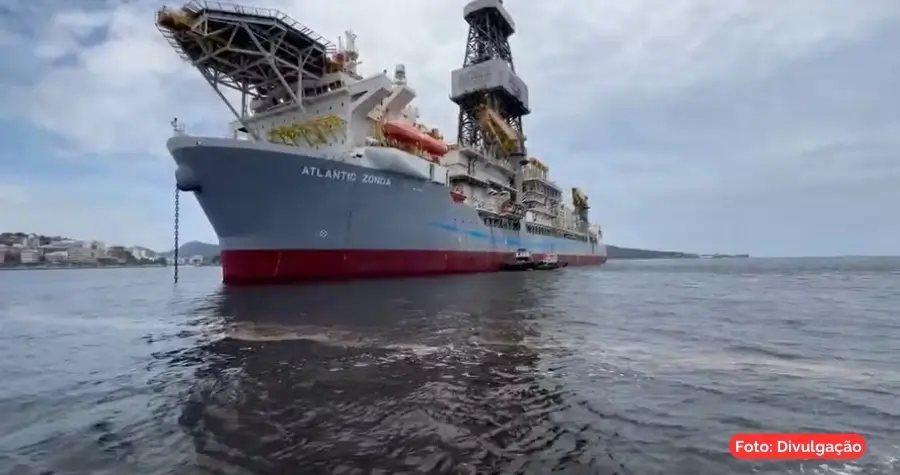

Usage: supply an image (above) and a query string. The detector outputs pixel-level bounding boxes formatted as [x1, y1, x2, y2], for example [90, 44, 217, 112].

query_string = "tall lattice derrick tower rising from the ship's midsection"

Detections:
[450, 0, 531, 156]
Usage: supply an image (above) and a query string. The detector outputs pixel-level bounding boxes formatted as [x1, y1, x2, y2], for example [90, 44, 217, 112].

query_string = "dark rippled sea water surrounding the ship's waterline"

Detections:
[0, 260, 900, 475]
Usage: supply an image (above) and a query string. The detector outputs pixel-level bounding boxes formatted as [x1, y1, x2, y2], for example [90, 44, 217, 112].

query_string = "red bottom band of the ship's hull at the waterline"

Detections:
[222, 250, 606, 285]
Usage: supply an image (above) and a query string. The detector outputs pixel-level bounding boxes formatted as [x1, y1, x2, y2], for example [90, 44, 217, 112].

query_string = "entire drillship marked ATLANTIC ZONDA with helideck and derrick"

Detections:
[156, 0, 606, 284]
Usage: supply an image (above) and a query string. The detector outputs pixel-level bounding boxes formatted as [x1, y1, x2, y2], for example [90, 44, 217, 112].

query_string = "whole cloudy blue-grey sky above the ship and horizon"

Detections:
[0, 0, 900, 256]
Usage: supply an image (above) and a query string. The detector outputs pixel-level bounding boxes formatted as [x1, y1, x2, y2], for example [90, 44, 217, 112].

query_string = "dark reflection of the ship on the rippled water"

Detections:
[170, 274, 621, 474]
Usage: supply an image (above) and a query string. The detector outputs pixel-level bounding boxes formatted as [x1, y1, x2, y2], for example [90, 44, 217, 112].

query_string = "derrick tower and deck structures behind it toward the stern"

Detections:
[442, 0, 600, 247]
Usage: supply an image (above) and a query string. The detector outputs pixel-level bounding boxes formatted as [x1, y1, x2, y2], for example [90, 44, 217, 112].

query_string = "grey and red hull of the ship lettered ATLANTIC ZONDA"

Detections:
[168, 137, 606, 284]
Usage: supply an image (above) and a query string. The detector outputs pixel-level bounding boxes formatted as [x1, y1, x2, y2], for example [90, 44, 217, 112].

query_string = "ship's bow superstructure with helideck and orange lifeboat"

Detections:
[157, 1, 447, 169]
